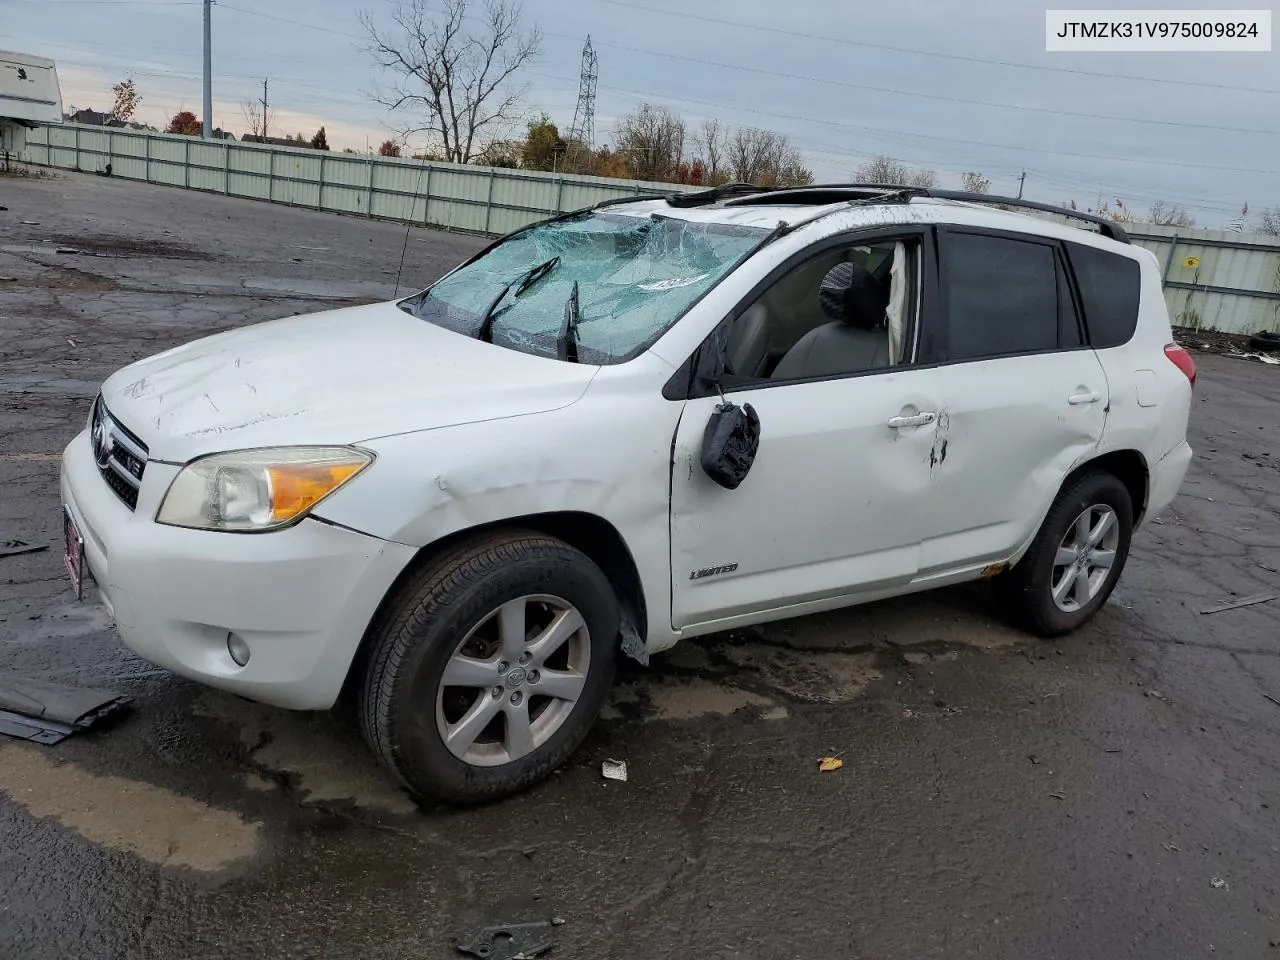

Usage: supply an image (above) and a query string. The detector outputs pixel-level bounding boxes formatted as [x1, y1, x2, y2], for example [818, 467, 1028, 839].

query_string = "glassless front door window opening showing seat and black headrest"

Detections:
[721, 238, 919, 384]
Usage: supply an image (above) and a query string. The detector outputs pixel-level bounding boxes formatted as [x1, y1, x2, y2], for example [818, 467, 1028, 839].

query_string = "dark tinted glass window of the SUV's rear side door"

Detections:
[943, 233, 1064, 360]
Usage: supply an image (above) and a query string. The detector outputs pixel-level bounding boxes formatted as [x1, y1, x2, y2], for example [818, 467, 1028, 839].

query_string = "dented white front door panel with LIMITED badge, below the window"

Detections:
[671, 370, 938, 628]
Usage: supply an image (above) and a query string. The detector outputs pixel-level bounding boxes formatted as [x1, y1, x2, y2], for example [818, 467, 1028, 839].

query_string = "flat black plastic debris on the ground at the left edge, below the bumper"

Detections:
[0, 671, 133, 746]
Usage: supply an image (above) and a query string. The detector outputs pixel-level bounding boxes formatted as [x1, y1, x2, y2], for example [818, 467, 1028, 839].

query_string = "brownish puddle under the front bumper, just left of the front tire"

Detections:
[193, 690, 417, 814]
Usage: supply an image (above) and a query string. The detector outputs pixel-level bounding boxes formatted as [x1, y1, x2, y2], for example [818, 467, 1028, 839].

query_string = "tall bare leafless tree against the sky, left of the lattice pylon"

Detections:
[360, 0, 541, 164]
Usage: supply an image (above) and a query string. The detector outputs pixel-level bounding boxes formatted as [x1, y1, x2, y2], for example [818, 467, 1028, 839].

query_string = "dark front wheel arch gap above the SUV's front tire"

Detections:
[343, 511, 649, 696]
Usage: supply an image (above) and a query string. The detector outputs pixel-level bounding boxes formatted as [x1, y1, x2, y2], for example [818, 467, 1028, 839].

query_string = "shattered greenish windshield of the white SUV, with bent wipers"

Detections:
[401, 212, 767, 364]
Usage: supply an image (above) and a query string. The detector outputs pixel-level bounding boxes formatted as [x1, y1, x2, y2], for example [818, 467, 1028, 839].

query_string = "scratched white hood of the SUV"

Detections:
[102, 303, 599, 462]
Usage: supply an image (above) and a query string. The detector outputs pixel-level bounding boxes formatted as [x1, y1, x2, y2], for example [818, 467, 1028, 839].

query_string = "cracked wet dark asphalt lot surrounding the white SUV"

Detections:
[0, 174, 1280, 960]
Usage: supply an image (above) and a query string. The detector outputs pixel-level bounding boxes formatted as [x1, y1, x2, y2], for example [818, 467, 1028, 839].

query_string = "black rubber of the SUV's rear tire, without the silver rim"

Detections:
[997, 470, 1133, 637]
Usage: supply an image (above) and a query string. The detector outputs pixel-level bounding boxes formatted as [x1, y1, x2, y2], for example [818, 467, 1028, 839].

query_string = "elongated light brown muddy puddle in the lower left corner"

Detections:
[0, 744, 261, 872]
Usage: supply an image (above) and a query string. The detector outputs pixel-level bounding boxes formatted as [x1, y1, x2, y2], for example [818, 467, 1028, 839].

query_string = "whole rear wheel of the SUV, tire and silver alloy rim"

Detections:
[1001, 471, 1133, 636]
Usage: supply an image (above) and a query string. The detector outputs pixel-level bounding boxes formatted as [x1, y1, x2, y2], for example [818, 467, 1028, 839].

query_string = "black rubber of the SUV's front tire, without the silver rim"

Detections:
[360, 530, 620, 804]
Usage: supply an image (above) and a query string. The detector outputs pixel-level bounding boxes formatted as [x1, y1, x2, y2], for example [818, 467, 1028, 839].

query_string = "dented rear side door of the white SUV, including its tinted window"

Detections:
[920, 228, 1108, 577]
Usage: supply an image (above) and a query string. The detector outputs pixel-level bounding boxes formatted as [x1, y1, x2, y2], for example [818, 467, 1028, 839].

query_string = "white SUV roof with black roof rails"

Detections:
[596, 184, 1128, 248]
